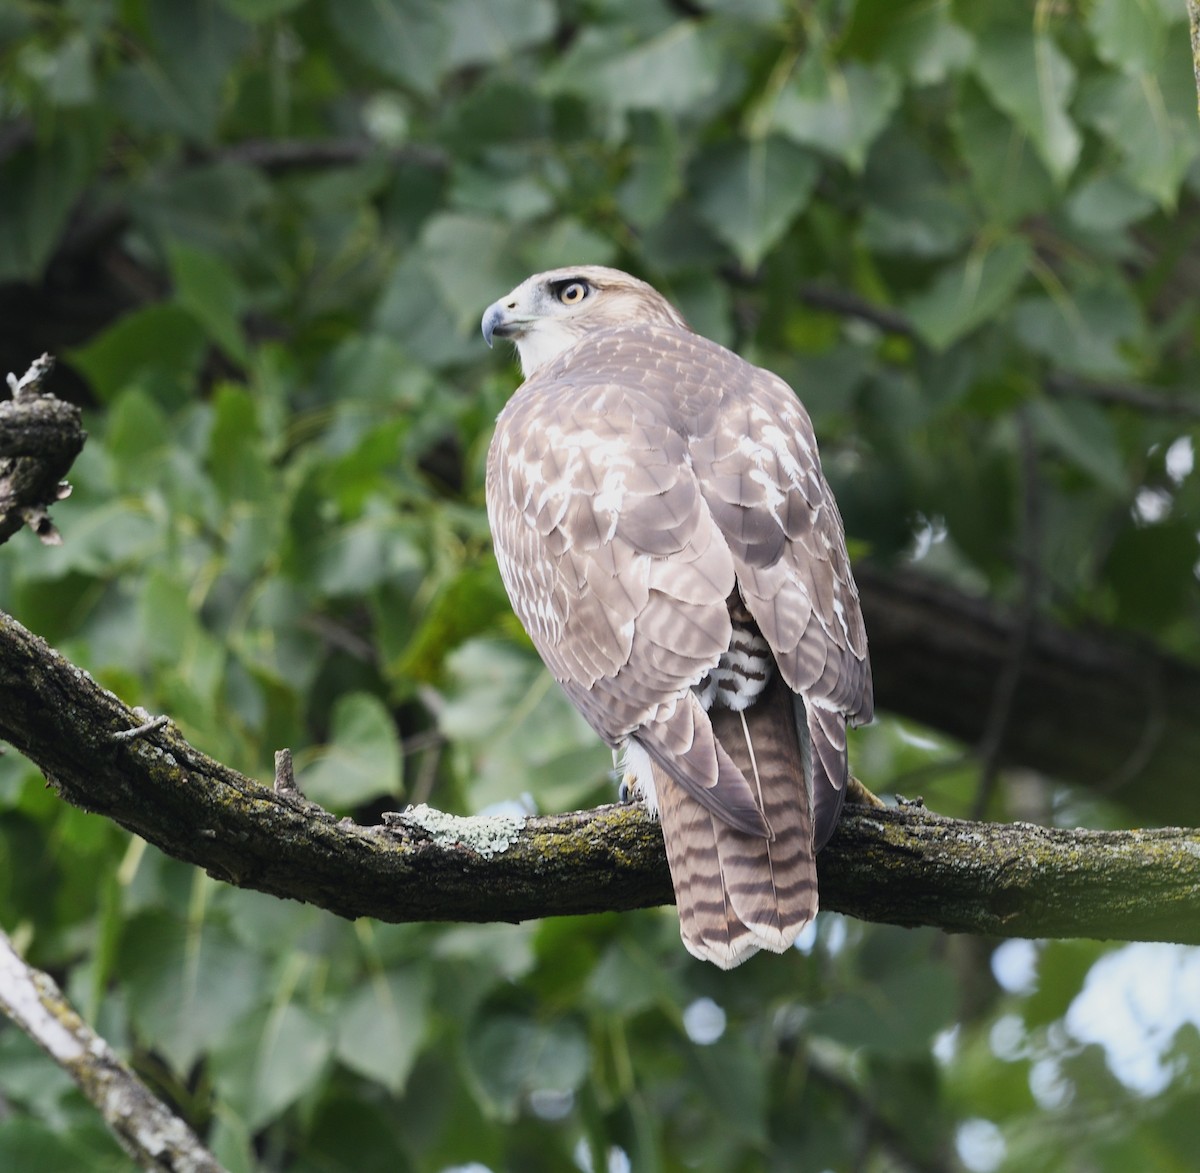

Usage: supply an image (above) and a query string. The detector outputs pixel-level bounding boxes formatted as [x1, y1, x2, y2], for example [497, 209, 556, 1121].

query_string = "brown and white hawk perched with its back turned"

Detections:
[482, 265, 872, 969]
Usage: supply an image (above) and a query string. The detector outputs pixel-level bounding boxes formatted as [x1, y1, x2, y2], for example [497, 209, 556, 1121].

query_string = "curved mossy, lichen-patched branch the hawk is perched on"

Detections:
[0, 614, 1200, 943]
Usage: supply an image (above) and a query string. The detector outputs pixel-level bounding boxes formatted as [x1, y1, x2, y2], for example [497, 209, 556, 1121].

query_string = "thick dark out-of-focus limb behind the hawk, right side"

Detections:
[854, 564, 1200, 825]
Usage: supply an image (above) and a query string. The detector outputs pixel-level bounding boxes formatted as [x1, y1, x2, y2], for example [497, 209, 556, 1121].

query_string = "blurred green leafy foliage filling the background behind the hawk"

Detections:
[0, 0, 1200, 1173]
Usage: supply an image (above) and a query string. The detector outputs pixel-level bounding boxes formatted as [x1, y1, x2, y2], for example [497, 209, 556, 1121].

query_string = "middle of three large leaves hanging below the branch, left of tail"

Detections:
[336, 969, 432, 1096]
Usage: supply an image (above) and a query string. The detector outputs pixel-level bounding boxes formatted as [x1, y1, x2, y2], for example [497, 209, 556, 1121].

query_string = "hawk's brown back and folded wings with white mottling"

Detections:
[487, 326, 871, 838]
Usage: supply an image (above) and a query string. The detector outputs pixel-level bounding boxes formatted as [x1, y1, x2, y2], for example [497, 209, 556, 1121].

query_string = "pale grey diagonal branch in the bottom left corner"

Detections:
[0, 932, 222, 1173]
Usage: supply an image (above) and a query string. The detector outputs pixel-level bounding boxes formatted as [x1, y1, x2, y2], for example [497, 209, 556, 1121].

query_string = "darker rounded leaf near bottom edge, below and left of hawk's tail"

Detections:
[467, 1015, 588, 1120]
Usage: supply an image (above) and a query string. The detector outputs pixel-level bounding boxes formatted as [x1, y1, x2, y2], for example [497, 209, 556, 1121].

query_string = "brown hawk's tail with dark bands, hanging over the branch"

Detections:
[654, 678, 817, 969]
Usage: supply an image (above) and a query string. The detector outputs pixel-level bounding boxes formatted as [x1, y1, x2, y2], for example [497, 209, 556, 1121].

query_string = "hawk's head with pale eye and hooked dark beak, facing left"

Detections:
[484, 265, 688, 378]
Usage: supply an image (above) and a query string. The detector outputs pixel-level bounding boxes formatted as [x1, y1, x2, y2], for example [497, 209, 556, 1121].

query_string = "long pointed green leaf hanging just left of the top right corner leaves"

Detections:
[976, 28, 1082, 182]
